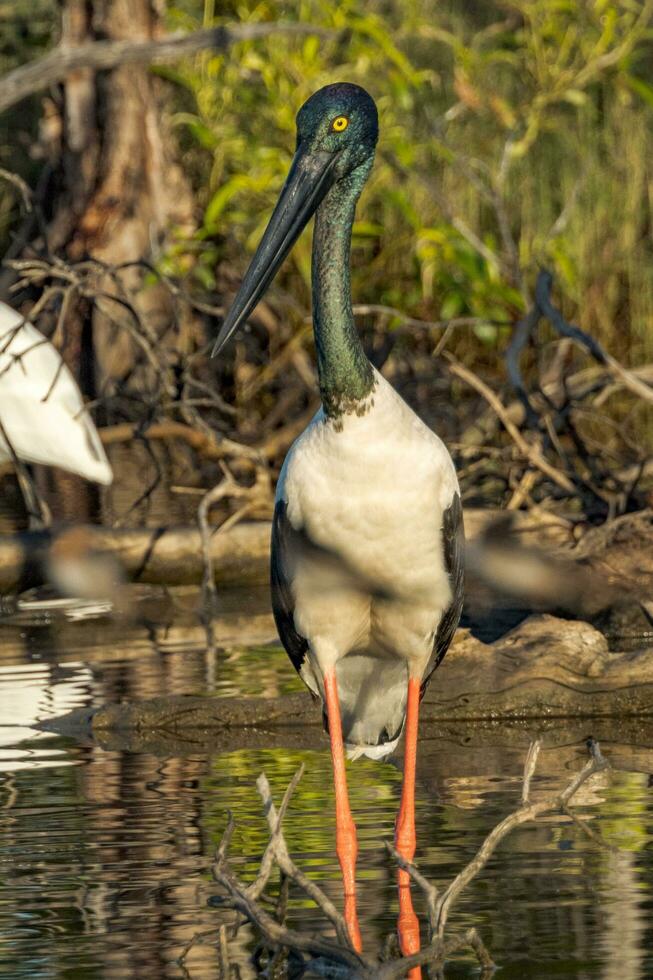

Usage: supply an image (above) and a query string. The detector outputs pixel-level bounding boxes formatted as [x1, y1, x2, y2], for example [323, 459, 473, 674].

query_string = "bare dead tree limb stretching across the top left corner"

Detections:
[0, 21, 334, 112]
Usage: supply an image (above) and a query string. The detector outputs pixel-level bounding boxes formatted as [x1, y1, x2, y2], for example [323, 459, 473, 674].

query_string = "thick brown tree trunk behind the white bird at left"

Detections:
[42, 0, 192, 519]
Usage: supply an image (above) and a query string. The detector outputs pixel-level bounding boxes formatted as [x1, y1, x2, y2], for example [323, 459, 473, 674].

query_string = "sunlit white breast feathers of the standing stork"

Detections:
[277, 373, 458, 672]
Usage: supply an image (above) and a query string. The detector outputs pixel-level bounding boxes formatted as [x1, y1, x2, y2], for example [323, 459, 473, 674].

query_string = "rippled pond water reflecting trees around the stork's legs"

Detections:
[0, 596, 653, 980]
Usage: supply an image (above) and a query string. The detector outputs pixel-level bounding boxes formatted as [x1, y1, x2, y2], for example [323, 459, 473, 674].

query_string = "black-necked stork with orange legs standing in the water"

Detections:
[214, 83, 464, 953]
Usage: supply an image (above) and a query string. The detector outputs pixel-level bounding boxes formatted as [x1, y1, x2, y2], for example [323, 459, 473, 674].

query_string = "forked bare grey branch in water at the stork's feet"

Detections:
[179, 737, 609, 980]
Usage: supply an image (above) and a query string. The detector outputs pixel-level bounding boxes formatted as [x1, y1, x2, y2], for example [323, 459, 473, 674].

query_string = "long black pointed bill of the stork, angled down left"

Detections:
[211, 148, 338, 357]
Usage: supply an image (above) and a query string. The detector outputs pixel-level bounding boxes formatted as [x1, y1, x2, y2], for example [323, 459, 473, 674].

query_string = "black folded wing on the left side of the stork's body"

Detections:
[270, 500, 308, 671]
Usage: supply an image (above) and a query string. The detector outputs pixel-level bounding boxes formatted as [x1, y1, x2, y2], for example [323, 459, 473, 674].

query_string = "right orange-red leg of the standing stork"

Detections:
[395, 677, 422, 980]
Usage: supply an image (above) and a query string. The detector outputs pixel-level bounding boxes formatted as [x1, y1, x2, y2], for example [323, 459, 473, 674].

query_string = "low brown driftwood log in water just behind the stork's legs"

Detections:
[44, 614, 653, 756]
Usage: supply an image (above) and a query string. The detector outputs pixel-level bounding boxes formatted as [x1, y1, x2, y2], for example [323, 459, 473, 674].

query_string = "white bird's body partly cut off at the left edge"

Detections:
[0, 294, 113, 485]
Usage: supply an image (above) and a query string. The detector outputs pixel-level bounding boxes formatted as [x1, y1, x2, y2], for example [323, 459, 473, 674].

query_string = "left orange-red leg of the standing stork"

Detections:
[324, 670, 363, 953]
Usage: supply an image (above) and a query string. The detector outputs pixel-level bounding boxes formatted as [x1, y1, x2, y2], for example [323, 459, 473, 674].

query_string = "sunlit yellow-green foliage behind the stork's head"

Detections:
[163, 0, 653, 360]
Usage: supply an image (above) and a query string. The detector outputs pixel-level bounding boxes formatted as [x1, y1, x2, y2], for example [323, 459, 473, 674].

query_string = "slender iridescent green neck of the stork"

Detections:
[312, 157, 374, 419]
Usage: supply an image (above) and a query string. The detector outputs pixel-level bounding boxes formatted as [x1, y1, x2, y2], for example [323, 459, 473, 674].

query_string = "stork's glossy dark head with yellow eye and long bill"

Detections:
[213, 82, 379, 354]
